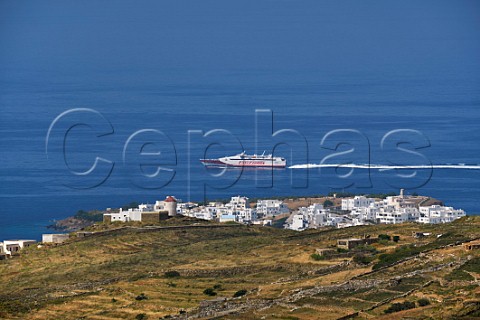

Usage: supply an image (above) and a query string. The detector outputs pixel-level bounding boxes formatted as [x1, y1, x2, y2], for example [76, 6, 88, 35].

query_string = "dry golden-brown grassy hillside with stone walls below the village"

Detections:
[0, 217, 480, 319]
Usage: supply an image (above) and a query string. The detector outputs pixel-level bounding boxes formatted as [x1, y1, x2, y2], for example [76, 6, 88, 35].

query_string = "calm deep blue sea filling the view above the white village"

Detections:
[0, 1, 480, 240]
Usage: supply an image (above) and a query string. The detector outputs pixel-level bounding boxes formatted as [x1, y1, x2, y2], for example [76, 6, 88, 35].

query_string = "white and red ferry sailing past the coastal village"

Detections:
[200, 151, 287, 168]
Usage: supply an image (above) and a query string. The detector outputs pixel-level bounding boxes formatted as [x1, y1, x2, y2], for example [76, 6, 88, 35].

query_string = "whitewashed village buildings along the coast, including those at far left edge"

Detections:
[0, 190, 466, 260]
